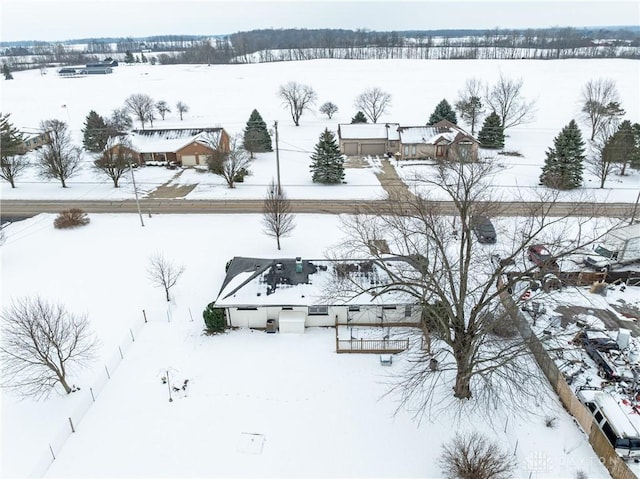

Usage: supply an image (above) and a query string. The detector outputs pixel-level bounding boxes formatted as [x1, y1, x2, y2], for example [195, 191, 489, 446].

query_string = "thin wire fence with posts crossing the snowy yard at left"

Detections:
[29, 310, 165, 478]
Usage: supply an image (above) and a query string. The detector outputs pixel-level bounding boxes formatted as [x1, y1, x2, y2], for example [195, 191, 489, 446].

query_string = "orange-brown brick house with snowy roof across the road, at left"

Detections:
[114, 127, 229, 166]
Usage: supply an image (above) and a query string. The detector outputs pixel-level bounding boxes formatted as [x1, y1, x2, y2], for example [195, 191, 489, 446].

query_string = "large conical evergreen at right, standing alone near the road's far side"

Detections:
[540, 120, 585, 190]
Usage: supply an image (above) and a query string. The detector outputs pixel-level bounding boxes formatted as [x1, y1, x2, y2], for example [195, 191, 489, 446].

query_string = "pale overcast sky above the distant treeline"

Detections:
[0, 0, 640, 41]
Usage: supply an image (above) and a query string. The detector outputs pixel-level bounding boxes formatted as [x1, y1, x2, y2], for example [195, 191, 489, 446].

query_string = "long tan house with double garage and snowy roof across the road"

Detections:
[338, 120, 480, 161]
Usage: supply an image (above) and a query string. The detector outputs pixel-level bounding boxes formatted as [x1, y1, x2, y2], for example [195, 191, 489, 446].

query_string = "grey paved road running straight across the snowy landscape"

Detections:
[0, 199, 634, 218]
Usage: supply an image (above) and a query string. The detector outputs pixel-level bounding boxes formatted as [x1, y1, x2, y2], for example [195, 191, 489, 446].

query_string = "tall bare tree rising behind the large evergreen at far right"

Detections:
[581, 78, 624, 141]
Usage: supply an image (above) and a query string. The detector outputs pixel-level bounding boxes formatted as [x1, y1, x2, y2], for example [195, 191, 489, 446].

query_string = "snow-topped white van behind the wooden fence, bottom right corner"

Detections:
[576, 387, 640, 460]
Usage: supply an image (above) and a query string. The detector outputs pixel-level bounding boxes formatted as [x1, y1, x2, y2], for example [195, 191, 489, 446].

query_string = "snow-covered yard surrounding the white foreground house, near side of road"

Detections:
[1, 214, 607, 479]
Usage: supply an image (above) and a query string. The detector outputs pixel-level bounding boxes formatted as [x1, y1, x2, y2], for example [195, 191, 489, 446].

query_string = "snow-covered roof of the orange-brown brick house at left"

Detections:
[127, 128, 222, 153]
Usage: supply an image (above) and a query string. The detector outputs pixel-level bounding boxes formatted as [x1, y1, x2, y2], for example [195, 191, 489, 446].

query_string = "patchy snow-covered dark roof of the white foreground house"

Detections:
[216, 257, 415, 307]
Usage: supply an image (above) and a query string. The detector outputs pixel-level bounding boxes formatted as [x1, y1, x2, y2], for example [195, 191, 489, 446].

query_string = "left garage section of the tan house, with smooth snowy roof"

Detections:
[338, 123, 400, 156]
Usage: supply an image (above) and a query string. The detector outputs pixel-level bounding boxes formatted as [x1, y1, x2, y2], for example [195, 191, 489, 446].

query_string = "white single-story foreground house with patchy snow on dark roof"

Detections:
[215, 257, 421, 332]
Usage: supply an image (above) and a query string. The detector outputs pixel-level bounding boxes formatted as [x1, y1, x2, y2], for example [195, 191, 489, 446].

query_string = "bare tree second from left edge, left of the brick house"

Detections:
[38, 120, 82, 188]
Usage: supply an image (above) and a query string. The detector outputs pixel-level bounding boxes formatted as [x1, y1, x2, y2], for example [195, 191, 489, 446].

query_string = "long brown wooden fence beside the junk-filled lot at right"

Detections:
[499, 285, 637, 479]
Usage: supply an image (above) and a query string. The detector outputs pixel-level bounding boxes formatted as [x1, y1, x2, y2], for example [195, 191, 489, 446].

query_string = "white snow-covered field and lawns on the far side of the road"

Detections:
[0, 59, 640, 202]
